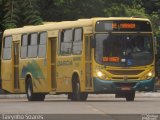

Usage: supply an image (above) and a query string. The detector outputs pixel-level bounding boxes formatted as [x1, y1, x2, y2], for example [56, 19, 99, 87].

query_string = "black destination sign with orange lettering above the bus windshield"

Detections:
[95, 20, 152, 32]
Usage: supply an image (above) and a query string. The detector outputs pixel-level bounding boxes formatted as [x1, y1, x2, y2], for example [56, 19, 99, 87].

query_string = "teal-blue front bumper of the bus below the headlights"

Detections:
[93, 78, 155, 93]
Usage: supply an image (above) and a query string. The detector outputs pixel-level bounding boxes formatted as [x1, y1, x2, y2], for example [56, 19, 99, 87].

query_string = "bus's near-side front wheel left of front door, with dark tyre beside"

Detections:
[70, 77, 88, 101]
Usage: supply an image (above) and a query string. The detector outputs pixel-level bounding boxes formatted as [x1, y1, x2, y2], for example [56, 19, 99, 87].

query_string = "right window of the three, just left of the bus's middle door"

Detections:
[38, 32, 47, 58]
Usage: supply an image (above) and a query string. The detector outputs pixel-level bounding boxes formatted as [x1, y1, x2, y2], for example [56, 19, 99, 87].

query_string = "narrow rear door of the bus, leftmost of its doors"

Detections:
[13, 42, 19, 92]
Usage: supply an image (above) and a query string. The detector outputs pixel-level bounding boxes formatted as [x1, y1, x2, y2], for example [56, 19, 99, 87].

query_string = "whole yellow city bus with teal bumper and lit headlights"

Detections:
[1, 17, 155, 101]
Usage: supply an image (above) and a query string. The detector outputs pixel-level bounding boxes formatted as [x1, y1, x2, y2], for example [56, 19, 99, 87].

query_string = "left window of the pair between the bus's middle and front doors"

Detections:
[60, 29, 73, 55]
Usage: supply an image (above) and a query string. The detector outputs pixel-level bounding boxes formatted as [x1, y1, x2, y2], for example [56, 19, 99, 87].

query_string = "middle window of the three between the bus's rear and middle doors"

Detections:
[28, 33, 38, 58]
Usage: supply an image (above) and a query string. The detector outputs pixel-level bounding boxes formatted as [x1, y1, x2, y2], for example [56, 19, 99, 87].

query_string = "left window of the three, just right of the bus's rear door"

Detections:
[21, 34, 28, 58]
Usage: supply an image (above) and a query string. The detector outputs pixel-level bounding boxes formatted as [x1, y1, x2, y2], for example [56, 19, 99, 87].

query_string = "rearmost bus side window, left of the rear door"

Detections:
[3, 36, 12, 60]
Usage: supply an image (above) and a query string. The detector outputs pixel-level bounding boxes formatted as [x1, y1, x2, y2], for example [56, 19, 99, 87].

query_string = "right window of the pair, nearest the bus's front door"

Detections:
[72, 28, 82, 54]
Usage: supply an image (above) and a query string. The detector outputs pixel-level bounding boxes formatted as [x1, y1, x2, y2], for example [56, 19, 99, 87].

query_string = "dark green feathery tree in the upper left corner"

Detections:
[0, 0, 43, 30]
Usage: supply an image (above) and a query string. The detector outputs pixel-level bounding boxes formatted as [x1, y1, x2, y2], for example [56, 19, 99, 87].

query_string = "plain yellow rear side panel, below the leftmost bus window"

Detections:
[1, 60, 14, 93]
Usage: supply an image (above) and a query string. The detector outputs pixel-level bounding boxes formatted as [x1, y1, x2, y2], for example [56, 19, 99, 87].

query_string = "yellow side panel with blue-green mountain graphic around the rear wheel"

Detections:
[20, 59, 49, 93]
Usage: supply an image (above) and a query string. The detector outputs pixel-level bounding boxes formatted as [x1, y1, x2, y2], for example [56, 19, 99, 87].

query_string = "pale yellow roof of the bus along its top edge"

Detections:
[4, 17, 150, 36]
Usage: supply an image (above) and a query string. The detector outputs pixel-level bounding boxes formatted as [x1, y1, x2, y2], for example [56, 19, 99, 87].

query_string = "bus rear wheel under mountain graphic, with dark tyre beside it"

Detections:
[26, 78, 45, 101]
